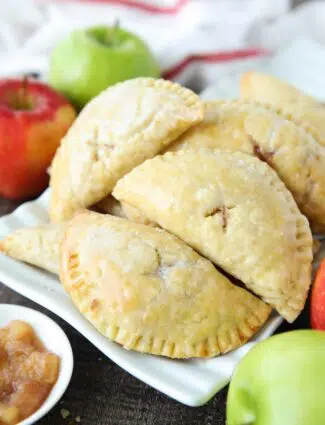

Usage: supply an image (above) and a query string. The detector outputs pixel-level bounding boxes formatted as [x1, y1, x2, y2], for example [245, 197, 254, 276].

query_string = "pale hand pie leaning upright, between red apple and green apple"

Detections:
[49, 78, 203, 222]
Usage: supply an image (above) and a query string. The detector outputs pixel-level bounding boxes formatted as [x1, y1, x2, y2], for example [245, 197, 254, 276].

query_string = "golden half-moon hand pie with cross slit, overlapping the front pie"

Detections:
[113, 149, 312, 322]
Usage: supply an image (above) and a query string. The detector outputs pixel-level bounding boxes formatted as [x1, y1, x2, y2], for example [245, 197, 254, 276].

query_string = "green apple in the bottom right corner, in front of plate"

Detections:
[227, 330, 325, 425]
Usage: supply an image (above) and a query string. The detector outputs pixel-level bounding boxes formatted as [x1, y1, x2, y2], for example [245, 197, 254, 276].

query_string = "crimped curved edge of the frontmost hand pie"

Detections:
[60, 211, 272, 359]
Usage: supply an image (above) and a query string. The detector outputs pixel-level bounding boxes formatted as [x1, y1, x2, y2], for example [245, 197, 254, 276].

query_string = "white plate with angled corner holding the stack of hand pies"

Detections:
[0, 192, 282, 406]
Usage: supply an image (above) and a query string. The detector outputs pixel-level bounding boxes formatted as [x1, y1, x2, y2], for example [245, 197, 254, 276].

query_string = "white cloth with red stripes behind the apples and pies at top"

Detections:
[0, 0, 325, 91]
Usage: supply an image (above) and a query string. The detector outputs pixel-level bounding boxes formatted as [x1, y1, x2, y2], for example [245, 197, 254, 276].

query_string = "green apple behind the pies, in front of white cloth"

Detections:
[49, 25, 159, 108]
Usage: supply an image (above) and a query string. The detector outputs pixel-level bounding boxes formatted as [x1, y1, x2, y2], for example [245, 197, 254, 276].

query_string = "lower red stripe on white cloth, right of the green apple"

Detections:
[163, 49, 268, 80]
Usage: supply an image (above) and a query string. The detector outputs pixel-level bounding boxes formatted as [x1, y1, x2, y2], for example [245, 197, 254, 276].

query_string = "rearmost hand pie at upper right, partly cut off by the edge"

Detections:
[240, 71, 325, 145]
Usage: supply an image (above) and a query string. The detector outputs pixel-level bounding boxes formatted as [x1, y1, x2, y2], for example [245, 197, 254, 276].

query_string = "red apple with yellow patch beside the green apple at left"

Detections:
[0, 79, 76, 199]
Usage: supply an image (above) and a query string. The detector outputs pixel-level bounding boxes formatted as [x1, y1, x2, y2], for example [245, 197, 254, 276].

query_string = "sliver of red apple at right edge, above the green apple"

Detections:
[310, 259, 325, 331]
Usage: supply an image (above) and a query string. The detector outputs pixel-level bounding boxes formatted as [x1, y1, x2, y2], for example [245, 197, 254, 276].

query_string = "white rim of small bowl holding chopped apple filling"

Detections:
[0, 304, 73, 425]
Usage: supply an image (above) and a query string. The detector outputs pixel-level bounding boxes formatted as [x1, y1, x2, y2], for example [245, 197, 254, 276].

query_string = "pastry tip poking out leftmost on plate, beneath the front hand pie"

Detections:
[0, 224, 65, 274]
